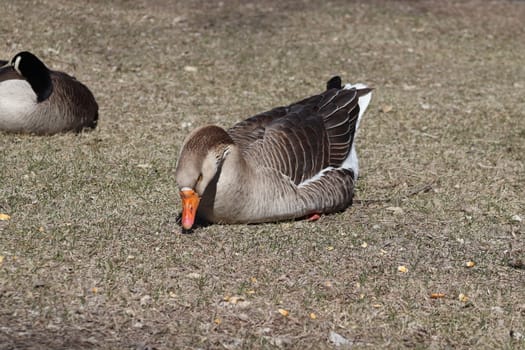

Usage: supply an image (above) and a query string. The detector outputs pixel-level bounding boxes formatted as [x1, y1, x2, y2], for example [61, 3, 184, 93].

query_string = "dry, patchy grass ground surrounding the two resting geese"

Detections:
[0, 0, 525, 349]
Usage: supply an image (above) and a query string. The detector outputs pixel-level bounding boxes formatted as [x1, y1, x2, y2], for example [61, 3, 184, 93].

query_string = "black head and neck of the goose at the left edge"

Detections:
[9, 51, 53, 102]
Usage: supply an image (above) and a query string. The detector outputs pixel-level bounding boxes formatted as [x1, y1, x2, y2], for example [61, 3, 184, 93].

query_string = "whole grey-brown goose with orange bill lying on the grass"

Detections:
[175, 76, 372, 230]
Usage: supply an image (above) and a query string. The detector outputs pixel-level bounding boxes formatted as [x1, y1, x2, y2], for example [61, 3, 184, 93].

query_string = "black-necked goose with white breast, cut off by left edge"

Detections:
[0, 51, 98, 135]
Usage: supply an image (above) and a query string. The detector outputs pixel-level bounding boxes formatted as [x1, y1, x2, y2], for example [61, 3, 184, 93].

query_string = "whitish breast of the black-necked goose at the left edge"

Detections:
[0, 79, 37, 130]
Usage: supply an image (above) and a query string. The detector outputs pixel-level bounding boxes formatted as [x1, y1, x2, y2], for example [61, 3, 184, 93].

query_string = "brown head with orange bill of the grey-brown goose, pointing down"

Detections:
[175, 125, 233, 230]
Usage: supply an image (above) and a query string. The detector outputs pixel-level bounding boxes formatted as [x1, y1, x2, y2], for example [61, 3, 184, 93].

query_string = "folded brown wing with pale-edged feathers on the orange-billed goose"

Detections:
[238, 88, 370, 185]
